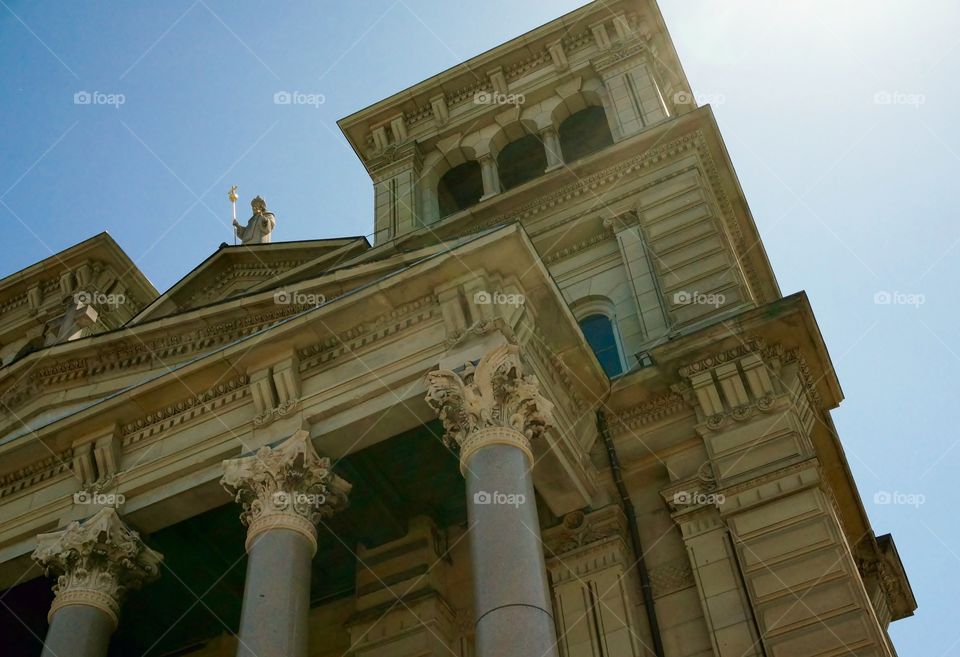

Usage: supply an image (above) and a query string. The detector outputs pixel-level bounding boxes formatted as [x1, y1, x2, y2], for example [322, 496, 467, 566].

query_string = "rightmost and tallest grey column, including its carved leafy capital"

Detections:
[427, 345, 557, 657]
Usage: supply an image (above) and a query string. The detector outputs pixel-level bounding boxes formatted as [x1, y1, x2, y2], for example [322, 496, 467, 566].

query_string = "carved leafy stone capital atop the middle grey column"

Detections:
[220, 430, 351, 550]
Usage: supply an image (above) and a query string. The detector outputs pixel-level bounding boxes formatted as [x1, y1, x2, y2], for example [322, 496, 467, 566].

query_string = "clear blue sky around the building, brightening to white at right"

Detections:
[0, 0, 960, 657]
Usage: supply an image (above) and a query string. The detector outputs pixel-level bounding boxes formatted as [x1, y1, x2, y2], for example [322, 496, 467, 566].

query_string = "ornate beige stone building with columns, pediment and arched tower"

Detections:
[0, 0, 916, 657]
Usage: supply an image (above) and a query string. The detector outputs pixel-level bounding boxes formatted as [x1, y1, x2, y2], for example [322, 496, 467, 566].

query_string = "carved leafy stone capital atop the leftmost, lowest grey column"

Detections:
[33, 508, 163, 625]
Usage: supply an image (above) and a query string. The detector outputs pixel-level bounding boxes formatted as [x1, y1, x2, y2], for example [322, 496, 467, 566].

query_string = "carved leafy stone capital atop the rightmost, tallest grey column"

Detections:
[426, 344, 553, 464]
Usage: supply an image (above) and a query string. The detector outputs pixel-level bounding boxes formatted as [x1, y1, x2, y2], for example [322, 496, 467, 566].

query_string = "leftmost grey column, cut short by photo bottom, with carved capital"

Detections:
[33, 508, 163, 657]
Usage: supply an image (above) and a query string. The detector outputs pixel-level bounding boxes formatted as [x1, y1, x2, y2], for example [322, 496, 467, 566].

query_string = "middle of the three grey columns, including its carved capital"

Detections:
[220, 431, 350, 657]
